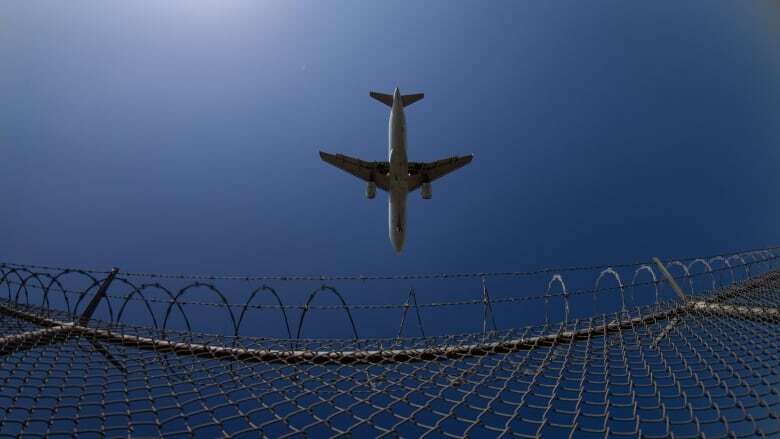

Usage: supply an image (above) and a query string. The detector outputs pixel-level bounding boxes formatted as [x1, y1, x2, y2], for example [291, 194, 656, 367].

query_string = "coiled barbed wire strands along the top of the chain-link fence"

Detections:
[0, 246, 778, 335]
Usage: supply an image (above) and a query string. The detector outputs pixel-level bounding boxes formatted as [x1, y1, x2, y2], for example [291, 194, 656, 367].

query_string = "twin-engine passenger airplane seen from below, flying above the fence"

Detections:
[320, 87, 474, 253]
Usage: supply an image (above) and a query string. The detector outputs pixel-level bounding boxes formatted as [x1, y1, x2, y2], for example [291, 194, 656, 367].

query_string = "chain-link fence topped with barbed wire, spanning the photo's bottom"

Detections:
[0, 249, 780, 437]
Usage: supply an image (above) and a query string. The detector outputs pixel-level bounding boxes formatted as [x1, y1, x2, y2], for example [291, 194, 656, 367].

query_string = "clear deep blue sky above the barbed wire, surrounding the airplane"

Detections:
[0, 1, 780, 274]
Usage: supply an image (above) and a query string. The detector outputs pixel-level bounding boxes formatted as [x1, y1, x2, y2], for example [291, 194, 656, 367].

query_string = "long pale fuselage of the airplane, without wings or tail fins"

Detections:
[388, 88, 409, 252]
